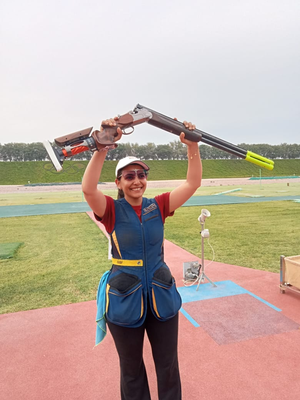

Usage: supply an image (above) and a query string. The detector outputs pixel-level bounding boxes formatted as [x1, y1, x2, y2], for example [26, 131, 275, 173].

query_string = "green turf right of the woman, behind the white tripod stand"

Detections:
[165, 201, 300, 274]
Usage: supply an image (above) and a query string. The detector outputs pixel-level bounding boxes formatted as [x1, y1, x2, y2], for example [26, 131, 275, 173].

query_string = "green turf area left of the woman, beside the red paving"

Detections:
[0, 214, 111, 313]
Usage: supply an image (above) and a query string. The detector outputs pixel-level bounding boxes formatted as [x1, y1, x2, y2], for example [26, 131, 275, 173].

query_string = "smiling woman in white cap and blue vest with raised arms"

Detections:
[82, 118, 202, 400]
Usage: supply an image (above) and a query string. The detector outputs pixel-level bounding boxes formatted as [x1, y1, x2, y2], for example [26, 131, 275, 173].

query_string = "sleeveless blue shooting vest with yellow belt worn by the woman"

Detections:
[106, 198, 181, 328]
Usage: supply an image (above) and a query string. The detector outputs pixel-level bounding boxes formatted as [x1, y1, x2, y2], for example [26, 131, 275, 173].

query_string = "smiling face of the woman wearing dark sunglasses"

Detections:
[115, 164, 147, 205]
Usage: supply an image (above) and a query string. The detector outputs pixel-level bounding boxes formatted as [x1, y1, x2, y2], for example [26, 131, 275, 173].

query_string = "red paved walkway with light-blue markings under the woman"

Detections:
[0, 233, 300, 400]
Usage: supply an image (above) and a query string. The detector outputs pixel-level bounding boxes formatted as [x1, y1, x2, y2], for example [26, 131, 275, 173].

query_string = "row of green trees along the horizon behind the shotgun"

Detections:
[0, 141, 300, 162]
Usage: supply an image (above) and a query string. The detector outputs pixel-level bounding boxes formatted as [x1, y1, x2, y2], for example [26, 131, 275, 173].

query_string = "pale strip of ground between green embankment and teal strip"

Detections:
[0, 178, 300, 206]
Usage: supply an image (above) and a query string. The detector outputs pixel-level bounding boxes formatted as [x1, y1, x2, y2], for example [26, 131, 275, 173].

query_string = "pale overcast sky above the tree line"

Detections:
[0, 0, 300, 144]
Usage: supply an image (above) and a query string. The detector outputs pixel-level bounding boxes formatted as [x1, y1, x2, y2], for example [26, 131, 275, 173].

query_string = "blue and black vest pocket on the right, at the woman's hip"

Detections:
[151, 266, 182, 320]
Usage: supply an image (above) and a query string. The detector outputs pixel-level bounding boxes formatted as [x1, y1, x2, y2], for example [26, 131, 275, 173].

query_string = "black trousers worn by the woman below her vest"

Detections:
[107, 306, 181, 400]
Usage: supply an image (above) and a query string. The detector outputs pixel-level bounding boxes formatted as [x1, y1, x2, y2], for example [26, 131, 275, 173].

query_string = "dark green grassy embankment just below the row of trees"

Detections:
[0, 159, 300, 185]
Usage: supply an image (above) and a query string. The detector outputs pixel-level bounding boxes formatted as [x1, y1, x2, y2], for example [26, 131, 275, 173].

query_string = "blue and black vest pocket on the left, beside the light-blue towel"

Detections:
[106, 272, 144, 326]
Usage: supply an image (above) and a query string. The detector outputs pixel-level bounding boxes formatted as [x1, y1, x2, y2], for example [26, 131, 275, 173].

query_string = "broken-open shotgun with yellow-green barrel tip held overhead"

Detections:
[43, 104, 274, 171]
